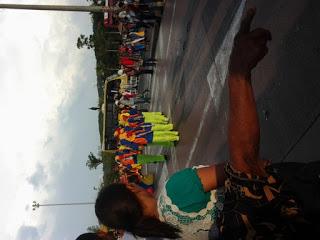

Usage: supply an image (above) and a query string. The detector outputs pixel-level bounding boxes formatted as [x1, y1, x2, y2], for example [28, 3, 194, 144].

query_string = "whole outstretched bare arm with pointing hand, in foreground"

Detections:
[228, 9, 271, 176]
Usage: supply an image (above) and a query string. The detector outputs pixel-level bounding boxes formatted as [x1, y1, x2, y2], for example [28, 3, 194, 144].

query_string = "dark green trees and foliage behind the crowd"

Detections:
[76, 0, 121, 188]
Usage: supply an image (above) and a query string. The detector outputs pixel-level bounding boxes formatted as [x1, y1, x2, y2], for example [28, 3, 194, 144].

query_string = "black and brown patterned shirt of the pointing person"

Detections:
[218, 164, 302, 240]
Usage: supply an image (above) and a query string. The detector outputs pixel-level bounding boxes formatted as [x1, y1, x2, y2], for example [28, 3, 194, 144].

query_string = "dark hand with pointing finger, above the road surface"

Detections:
[229, 8, 271, 75]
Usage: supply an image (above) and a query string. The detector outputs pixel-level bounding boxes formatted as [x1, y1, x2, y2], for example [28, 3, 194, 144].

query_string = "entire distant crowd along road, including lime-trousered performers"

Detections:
[106, 1, 179, 199]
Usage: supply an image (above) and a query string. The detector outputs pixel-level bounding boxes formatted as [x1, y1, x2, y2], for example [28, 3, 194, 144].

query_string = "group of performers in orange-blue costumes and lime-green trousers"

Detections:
[114, 108, 179, 193]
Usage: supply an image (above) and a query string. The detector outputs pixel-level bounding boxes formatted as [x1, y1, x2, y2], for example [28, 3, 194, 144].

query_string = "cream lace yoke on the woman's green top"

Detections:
[158, 166, 224, 239]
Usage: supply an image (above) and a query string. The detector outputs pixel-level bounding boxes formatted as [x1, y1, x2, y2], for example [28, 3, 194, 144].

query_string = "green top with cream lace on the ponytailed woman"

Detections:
[158, 168, 223, 239]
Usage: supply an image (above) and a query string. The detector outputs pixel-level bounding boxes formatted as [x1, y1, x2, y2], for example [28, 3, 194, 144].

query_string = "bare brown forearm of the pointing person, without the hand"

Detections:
[228, 72, 260, 174]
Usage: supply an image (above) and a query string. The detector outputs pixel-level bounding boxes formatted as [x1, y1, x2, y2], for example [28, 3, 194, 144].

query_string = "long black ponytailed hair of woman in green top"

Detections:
[95, 183, 180, 239]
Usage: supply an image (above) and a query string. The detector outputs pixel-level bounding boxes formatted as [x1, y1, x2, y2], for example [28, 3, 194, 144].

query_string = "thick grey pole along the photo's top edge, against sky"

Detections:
[0, 4, 116, 13]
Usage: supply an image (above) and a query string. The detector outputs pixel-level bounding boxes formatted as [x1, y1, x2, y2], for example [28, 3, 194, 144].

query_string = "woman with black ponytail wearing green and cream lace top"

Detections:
[95, 162, 224, 239]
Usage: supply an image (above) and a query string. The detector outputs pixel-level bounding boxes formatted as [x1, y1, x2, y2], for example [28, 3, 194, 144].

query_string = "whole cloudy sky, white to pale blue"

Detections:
[0, 0, 102, 240]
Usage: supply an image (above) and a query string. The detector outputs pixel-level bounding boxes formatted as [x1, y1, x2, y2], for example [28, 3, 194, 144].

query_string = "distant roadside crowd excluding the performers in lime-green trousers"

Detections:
[106, 1, 163, 109]
